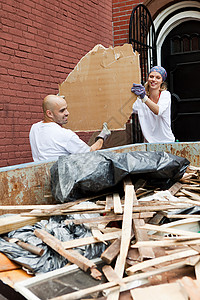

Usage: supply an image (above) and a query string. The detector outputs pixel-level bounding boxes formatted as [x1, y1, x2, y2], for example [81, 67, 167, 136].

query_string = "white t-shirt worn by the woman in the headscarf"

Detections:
[133, 91, 175, 143]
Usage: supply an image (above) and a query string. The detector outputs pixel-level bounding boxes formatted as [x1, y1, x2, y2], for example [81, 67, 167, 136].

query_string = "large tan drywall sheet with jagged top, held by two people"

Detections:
[59, 44, 141, 131]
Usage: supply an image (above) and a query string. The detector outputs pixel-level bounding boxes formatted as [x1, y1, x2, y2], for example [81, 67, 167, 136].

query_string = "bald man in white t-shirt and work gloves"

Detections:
[29, 95, 111, 162]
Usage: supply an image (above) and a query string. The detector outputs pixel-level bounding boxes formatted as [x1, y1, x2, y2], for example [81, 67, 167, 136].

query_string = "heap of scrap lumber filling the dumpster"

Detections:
[0, 166, 200, 300]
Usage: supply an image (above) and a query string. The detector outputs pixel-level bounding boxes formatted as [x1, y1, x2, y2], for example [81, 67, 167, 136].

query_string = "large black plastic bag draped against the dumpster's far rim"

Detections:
[51, 151, 189, 202]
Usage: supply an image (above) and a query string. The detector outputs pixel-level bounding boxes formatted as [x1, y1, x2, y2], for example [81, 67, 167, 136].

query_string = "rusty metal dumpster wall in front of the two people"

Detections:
[0, 142, 200, 207]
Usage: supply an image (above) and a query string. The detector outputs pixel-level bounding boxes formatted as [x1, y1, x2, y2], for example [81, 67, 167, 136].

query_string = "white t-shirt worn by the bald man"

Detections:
[29, 121, 90, 162]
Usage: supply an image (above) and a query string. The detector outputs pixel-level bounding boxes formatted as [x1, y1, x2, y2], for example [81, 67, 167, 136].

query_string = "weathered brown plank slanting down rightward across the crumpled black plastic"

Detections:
[34, 229, 101, 279]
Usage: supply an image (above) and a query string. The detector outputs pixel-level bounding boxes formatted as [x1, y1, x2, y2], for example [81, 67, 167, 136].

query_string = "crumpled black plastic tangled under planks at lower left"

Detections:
[0, 214, 106, 273]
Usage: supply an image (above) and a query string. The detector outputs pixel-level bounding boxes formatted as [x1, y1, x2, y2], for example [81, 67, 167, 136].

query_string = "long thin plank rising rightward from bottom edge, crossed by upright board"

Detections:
[48, 260, 189, 300]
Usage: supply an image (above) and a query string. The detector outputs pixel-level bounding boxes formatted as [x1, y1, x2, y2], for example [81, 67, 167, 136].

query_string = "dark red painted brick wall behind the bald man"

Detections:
[0, 0, 113, 167]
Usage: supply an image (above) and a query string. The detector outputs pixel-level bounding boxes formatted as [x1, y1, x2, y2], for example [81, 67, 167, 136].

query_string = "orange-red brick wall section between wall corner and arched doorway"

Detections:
[112, 0, 143, 46]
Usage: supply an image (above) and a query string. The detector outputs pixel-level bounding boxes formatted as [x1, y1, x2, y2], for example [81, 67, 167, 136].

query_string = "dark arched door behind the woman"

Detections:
[162, 21, 200, 141]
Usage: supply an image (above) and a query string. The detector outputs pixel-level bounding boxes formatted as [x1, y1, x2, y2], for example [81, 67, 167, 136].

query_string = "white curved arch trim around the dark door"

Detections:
[154, 1, 200, 65]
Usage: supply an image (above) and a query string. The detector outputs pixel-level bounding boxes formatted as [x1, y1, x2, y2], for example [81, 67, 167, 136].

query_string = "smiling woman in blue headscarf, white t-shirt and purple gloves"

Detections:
[131, 66, 175, 143]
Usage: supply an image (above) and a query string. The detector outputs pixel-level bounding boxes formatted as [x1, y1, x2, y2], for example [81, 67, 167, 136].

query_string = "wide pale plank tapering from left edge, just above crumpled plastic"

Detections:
[0, 214, 42, 234]
